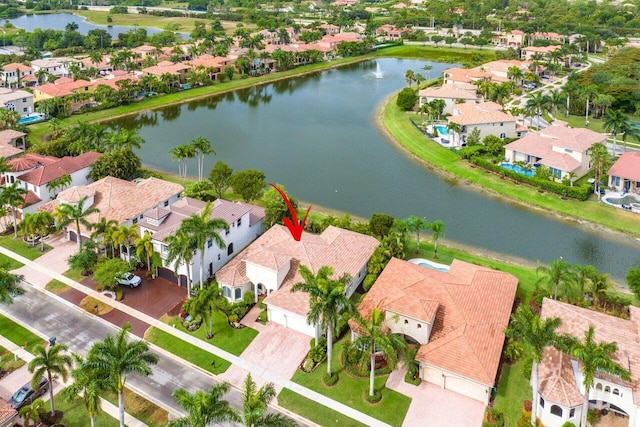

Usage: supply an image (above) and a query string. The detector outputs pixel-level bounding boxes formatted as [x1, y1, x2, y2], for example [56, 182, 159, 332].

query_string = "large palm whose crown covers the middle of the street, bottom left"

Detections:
[86, 323, 158, 427]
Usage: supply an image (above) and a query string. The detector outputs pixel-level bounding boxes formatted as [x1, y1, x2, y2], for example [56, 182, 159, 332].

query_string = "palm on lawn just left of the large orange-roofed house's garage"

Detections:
[350, 307, 407, 396]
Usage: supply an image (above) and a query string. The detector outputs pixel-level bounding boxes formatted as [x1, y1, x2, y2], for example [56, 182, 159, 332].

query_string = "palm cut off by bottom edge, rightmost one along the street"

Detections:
[242, 374, 298, 427]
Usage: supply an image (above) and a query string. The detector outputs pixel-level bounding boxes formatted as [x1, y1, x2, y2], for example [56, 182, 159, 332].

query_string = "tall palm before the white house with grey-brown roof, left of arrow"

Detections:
[180, 202, 229, 289]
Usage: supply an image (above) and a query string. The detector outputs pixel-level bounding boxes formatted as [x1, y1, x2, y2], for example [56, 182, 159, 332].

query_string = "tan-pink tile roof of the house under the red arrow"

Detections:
[216, 225, 380, 315]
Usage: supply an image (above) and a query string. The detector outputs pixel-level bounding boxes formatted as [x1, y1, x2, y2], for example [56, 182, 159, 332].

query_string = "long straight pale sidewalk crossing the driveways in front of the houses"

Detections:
[0, 247, 387, 426]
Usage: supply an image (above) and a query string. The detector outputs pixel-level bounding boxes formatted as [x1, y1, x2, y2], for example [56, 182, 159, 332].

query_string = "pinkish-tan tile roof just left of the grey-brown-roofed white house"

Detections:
[39, 176, 184, 234]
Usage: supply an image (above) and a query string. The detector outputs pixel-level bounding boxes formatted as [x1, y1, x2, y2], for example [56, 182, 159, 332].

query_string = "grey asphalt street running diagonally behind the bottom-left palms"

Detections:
[0, 284, 308, 426]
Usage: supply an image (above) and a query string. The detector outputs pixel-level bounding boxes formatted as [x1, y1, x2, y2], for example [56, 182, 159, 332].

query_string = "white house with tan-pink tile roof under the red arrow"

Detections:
[216, 225, 380, 338]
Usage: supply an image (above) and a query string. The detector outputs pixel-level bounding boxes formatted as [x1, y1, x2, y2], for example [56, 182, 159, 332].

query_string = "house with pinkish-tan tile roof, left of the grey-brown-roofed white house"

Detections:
[39, 176, 184, 246]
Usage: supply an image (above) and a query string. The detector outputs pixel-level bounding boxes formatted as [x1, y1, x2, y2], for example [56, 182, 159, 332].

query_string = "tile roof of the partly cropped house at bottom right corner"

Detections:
[539, 298, 640, 405]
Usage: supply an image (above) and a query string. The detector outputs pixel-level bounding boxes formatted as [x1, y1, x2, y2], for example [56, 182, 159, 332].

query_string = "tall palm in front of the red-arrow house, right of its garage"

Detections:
[291, 264, 354, 377]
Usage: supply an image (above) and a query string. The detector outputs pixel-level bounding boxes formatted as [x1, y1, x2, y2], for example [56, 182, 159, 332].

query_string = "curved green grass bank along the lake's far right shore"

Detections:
[382, 100, 640, 241]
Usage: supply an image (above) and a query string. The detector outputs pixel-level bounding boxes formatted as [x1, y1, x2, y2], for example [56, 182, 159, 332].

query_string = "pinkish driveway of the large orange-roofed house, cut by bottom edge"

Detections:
[387, 368, 485, 427]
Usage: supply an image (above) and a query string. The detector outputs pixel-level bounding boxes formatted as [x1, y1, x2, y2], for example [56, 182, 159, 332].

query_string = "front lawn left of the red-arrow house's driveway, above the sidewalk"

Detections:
[160, 312, 258, 356]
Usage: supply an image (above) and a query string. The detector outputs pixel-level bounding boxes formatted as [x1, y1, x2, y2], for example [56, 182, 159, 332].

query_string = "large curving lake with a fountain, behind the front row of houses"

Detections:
[112, 59, 640, 282]
